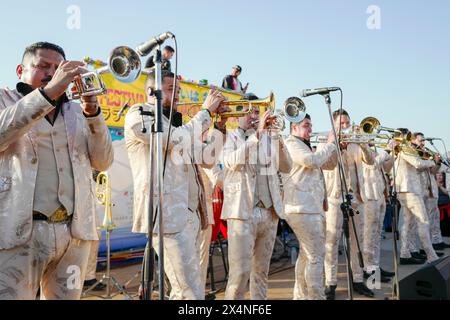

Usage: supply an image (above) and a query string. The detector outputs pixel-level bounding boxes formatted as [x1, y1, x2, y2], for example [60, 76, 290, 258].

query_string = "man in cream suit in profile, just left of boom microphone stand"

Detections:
[282, 115, 337, 300]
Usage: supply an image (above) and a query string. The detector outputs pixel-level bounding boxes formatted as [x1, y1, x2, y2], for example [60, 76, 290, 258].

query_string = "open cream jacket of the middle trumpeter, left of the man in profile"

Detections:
[221, 129, 292, 220]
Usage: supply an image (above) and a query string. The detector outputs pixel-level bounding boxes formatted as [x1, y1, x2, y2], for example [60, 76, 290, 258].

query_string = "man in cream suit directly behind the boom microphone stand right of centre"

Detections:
[317, 110, 375, 300]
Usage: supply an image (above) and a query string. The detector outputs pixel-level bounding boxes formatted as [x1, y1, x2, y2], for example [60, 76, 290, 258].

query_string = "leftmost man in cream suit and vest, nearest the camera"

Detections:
[0, 42, 113, 299]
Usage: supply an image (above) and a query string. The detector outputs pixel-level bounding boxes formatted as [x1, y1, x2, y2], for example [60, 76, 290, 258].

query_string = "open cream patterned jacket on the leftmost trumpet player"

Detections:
[0, 89, 113, 249]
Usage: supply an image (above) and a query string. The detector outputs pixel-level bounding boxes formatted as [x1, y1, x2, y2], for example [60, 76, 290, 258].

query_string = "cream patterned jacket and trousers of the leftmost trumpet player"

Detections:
[0, 89, 113, 299]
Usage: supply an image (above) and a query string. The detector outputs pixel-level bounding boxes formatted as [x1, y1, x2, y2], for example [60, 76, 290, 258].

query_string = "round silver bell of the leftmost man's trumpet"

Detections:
[109, 46, 141, 83]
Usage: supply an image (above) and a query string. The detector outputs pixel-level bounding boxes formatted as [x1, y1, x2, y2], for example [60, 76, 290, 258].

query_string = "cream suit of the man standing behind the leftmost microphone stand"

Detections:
[125, 104, 222, 300]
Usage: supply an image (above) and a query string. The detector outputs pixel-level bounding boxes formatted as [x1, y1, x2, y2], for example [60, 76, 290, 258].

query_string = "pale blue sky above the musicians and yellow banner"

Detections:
[0, 0, 450, 150]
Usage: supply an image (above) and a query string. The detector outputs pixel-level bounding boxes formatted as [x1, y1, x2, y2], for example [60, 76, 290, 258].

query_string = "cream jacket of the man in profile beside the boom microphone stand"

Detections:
[282, 136, 337, 214]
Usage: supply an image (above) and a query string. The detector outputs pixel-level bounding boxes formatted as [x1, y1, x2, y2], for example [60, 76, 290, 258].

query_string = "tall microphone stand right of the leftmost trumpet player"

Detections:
[139, 45, 164, 300]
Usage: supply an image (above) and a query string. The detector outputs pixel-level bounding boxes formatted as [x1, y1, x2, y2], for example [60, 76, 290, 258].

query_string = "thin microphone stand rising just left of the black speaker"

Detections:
[389, 150, 400, 300]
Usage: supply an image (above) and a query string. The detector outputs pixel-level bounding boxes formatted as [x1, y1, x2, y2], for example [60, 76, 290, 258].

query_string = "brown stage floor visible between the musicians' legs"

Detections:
[83, 233, 450, 300]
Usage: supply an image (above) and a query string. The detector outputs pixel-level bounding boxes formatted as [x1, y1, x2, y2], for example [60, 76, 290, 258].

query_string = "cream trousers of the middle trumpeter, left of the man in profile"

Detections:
[225, 207, 278, 300]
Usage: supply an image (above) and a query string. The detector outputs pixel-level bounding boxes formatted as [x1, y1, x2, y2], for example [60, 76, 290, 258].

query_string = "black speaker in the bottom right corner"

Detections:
[400, 256, 450, 300]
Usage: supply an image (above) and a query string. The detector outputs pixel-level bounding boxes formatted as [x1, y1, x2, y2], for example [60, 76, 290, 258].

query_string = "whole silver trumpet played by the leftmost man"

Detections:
[66, 46, 141, 100]
